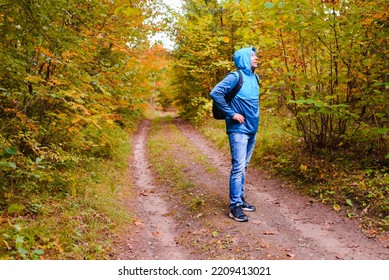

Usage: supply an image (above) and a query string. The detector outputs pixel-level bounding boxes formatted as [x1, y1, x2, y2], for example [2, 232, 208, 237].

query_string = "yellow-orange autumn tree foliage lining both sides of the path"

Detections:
[0, 0, 389, 258]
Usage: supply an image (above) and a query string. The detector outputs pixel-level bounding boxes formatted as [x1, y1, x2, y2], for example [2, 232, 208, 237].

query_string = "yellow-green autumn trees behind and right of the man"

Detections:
[176, 0, 389, 158]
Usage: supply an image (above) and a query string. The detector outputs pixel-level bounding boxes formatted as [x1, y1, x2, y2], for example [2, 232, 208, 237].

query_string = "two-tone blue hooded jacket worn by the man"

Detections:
[211, 48, 259, 134]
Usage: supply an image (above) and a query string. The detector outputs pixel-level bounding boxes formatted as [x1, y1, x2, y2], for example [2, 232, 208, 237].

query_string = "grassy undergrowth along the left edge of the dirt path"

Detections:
[0, 120, 137, 259]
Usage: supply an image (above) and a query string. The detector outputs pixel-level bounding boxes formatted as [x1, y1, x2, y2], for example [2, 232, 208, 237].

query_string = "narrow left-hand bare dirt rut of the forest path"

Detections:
[120, 121, 191, 260]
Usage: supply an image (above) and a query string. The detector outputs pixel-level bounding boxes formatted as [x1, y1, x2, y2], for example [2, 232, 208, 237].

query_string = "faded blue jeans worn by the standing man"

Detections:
[228, 133, 256, 207]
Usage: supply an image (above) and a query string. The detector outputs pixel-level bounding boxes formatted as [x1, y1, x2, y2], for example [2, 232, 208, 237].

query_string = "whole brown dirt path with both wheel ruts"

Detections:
[118, 117, 389, 260]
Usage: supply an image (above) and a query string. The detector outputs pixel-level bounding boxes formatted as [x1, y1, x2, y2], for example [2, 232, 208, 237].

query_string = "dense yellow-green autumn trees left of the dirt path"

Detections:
[0, 0, 165, 198]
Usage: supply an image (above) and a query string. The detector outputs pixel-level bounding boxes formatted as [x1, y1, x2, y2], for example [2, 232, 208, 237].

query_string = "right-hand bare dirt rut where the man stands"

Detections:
[176, 118, 389, 260]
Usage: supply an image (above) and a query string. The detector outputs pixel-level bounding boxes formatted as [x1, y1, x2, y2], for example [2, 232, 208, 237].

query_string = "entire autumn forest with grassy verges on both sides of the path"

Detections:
[0, 0, 389, 259]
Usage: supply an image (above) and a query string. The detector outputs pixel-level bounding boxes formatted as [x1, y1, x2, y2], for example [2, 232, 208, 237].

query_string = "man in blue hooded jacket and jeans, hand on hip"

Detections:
[211, 48, 259, 222]
